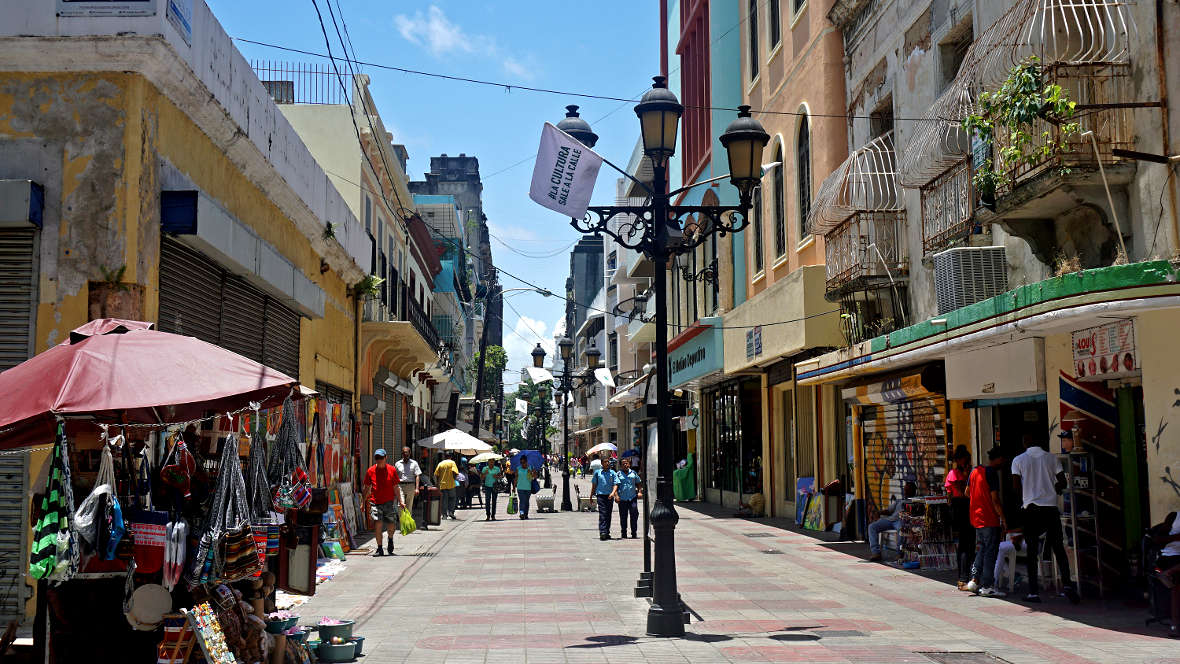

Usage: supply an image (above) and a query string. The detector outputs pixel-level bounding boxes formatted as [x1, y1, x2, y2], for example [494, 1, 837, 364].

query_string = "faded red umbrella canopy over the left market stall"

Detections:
[0, 318, 299, 448]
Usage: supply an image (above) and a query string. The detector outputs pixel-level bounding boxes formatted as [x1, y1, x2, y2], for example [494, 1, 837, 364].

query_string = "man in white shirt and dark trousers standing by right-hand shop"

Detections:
[1012, 433, 1081, 604]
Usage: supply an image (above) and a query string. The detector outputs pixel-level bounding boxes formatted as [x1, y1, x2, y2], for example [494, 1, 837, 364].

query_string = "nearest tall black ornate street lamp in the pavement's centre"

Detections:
[559, 77, 771, 637]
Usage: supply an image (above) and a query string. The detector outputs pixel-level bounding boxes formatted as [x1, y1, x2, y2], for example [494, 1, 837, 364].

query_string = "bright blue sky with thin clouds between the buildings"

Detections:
[207, 0, 660, 392]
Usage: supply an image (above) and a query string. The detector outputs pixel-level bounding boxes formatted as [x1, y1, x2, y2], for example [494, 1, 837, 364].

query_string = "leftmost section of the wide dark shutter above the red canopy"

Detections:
[157, 237, 222, 343]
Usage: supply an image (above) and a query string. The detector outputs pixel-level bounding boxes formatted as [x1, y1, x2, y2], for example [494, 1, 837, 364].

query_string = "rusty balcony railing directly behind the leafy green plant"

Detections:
[992, 63, 1135, 197]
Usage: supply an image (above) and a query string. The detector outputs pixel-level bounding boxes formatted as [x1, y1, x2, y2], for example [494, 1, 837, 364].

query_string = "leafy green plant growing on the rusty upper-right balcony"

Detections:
[962, 55, 1081, 210]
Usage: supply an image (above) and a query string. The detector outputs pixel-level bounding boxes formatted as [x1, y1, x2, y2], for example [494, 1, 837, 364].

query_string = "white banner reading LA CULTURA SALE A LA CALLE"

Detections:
[529, 123, 602, 219]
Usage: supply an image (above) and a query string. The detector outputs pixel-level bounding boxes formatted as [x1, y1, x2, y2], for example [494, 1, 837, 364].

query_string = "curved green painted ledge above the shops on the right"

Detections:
[868, 261, 1178, 353]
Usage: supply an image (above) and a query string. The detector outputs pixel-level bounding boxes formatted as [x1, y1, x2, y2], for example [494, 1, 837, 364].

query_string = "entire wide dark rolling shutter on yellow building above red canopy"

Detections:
[158, 237, 300, 379]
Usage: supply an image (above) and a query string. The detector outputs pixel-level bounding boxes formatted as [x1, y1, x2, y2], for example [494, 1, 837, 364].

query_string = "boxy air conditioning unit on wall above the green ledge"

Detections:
[933, 246, 1008, 314]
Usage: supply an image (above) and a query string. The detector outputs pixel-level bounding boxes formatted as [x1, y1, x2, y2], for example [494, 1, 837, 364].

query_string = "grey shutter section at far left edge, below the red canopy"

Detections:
[0, 454, 30, 623]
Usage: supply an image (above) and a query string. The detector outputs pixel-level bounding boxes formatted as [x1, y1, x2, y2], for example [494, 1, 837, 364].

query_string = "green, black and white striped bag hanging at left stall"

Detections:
[28, 422, 78, 581]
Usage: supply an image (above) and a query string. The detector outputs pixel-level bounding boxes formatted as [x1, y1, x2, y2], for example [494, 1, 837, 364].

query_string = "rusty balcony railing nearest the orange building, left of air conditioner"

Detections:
[824, 211, 909, 294]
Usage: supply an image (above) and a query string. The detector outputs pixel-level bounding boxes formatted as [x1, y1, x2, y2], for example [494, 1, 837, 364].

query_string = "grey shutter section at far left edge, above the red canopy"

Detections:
[0, 229, 37, 372]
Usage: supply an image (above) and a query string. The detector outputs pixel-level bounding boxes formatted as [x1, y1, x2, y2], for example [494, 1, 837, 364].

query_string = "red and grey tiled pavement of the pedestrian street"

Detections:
[290, 478, 1180, 664]
